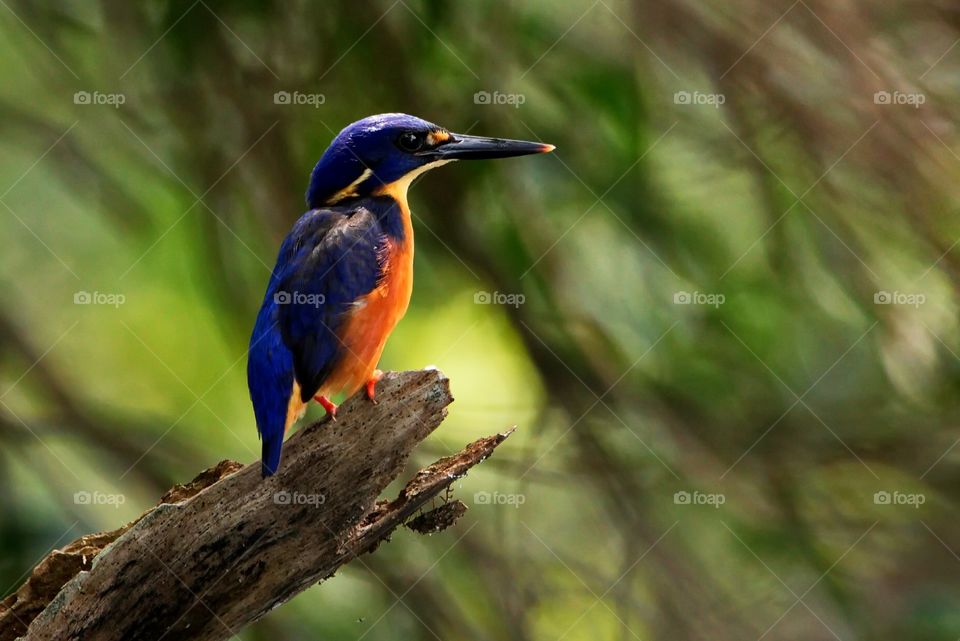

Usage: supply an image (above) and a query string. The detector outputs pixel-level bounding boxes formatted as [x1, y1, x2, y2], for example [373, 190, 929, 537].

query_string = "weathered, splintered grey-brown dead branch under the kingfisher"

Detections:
[0, 370, 509, 641]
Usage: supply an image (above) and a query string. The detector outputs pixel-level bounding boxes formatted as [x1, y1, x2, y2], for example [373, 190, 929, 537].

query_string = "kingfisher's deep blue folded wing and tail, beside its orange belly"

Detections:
[247, 205, 385, 476]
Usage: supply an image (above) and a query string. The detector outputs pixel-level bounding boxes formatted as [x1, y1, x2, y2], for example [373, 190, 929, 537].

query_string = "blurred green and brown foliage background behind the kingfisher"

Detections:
[0, 0, 960, 641]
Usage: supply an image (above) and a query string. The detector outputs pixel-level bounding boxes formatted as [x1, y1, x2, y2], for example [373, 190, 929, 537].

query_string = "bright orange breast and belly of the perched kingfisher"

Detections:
[319, 199, 413, 397]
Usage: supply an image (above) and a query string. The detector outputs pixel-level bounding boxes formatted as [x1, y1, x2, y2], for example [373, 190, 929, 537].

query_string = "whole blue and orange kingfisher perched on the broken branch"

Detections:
[247, 113, 554, 477]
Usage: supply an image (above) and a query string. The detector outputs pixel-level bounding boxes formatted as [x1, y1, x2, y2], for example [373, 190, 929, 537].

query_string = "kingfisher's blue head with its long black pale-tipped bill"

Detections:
[307, 114, 553, 209]
